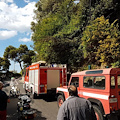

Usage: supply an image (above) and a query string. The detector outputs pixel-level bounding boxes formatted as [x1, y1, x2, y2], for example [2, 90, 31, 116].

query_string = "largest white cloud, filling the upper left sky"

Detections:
[0, 0, 35, 33]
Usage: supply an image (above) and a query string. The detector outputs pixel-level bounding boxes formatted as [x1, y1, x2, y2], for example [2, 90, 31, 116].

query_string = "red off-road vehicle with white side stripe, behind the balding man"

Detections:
[57, 68, 120, 120]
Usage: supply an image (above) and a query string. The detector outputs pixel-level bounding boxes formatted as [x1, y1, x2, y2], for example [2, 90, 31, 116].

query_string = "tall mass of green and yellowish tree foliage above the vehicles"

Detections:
[31, 0, 120, 71]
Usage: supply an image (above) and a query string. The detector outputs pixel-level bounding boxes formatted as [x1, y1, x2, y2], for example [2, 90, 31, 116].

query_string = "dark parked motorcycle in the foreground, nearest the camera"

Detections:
[17, 95, 36, 120]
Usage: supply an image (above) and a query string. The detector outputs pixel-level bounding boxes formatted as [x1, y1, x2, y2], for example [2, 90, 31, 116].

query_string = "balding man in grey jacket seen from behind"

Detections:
[57, 85, 97, 120]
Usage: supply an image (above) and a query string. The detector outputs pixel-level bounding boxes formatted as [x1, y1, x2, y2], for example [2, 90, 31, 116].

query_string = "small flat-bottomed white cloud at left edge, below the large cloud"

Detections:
[0, 31, 17, 40]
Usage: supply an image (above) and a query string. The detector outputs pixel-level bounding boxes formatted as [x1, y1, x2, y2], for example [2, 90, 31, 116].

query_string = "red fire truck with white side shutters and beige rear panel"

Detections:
[24, 61, 67, 98]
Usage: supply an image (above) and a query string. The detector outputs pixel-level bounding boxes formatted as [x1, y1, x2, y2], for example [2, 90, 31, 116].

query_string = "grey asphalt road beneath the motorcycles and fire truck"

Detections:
[3, 80, 58, 120]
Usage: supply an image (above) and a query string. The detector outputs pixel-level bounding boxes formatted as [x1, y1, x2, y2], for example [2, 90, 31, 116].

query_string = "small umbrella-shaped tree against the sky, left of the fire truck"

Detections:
[4, 45, 35, 71]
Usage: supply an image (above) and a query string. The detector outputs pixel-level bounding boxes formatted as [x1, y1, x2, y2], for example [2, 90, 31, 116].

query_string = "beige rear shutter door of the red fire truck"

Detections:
[47, 70, 60, 89]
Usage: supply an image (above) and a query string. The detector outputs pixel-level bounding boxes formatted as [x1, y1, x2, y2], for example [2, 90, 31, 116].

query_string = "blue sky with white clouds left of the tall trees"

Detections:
[0, 0, 38, 72]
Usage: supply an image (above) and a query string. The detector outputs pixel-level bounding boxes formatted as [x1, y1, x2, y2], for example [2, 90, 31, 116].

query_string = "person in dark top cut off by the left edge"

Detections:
[0, 81, 10, 120]
